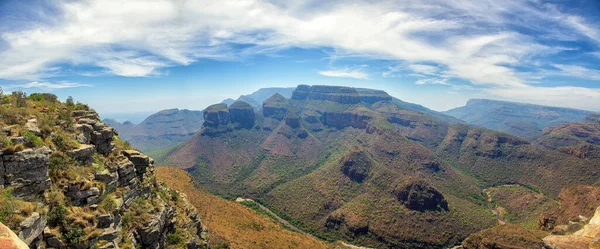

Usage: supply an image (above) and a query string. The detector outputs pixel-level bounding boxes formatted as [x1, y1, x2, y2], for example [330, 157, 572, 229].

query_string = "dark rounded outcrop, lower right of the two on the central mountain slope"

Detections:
[394, 179, 448, 212]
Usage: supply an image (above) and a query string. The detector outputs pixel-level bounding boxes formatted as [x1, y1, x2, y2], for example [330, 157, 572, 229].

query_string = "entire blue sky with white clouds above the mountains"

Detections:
[0, 0, 600, 120]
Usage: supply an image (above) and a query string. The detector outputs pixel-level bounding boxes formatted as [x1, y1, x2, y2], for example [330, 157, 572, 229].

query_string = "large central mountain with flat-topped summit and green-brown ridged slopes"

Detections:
[164, 85, 600, 248]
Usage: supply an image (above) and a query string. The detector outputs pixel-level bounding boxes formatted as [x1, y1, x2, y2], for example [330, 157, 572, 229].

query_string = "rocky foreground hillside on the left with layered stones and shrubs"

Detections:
[0, 92, 208, 249]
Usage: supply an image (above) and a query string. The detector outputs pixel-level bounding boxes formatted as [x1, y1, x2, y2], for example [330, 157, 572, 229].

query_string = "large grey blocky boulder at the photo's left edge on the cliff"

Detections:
[2, 147, 51, 197]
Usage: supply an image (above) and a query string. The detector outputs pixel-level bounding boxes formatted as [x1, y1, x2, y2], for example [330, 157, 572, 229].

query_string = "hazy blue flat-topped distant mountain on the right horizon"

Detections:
[443, 99, 591, 139]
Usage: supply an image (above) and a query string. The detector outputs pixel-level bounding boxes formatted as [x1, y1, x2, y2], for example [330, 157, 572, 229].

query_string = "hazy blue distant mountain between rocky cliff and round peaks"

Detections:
[104, 109, 204, 154]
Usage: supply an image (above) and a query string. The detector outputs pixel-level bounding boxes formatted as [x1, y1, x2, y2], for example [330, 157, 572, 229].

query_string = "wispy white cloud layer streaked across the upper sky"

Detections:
[0, 0, 600, 109]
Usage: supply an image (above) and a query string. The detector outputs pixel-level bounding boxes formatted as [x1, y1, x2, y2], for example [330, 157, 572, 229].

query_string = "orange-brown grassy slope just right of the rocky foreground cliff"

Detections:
[156, 167, 326, 248]
